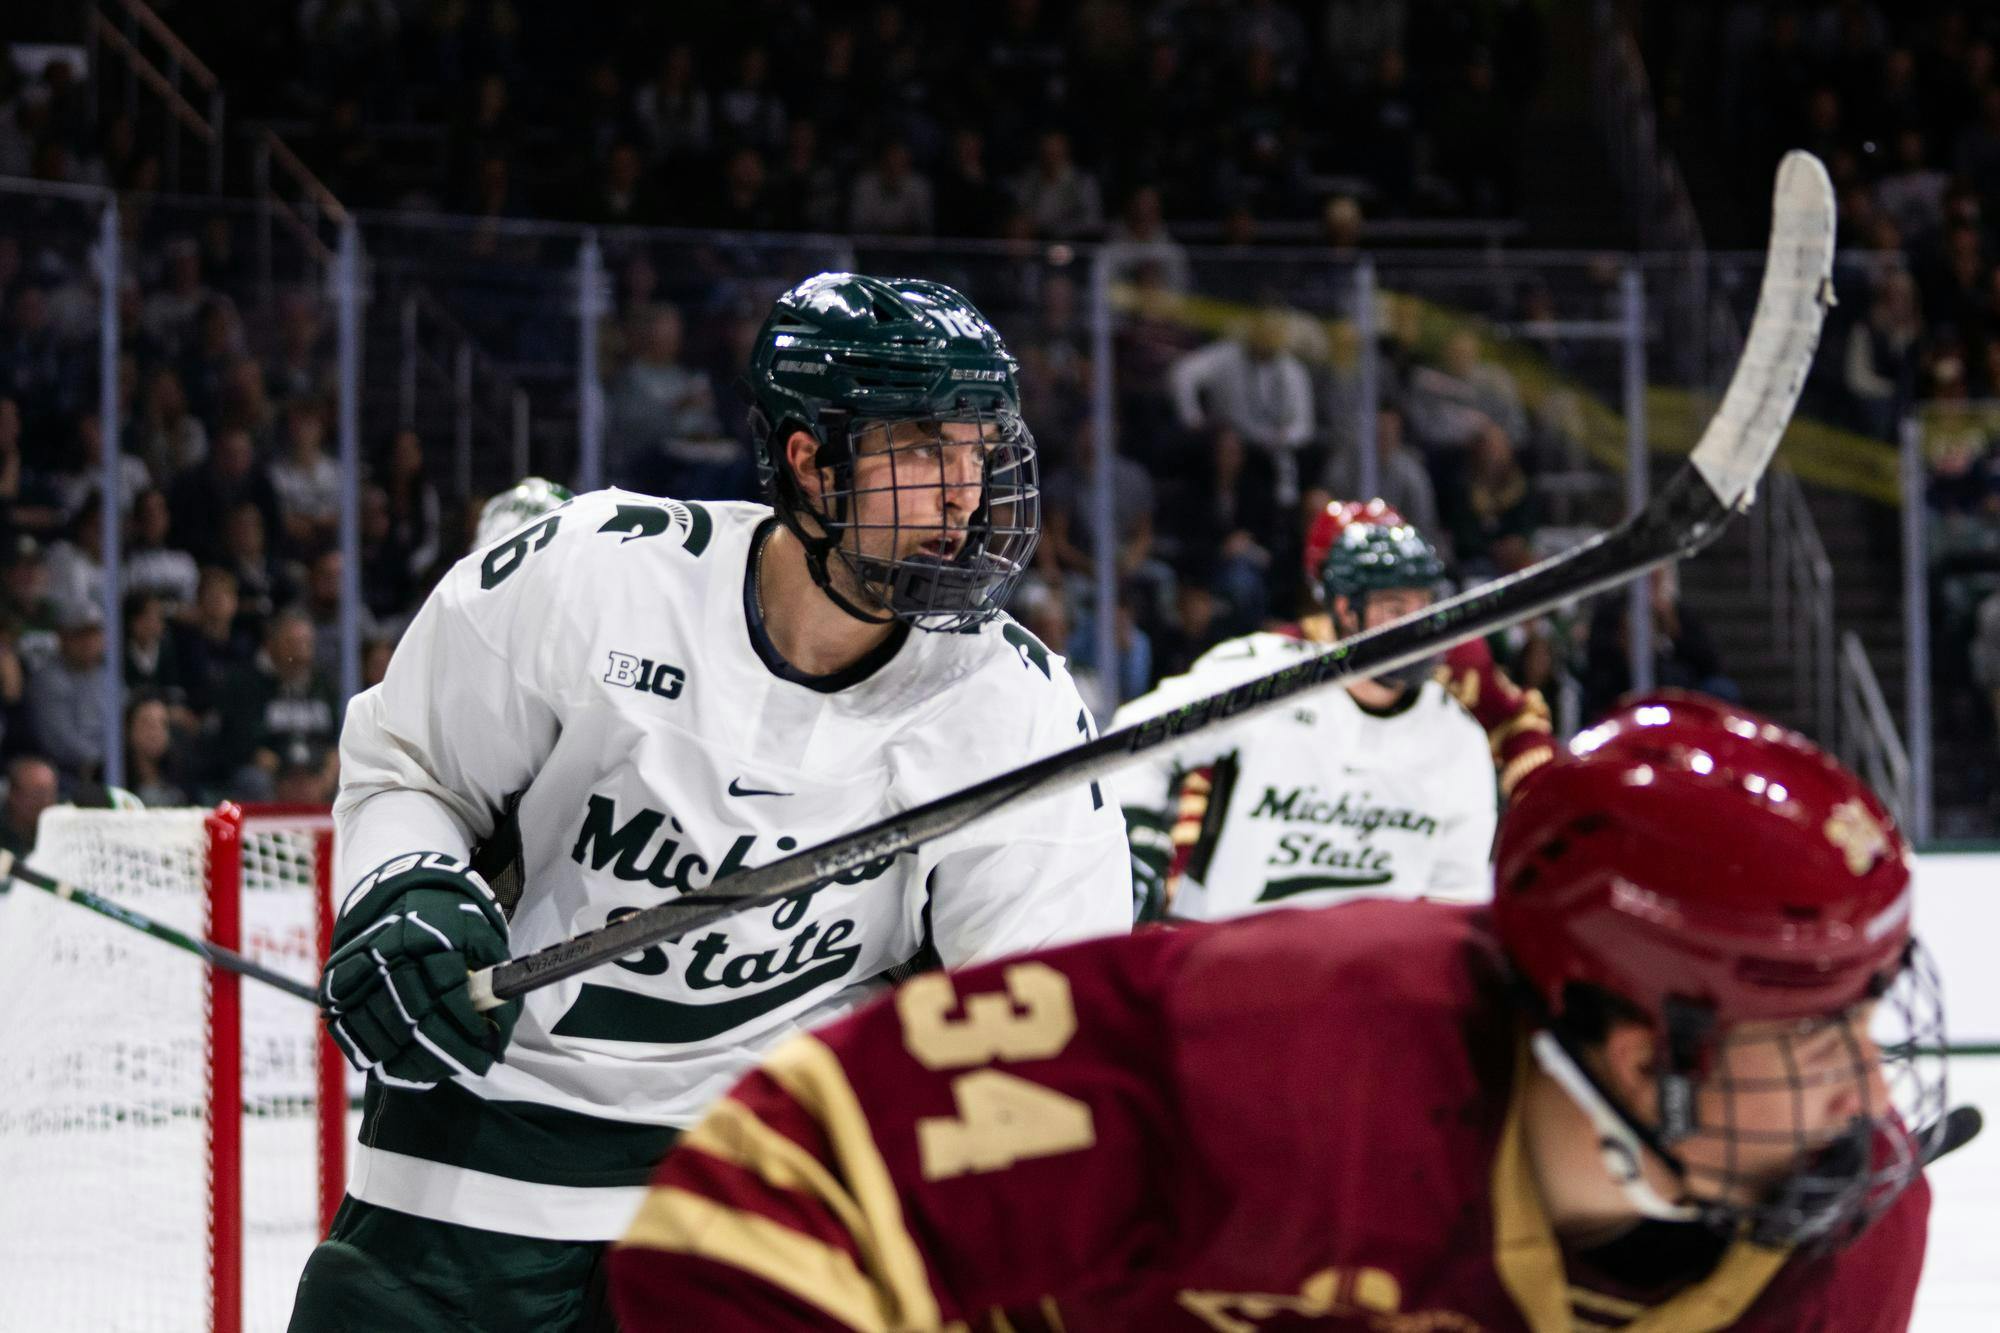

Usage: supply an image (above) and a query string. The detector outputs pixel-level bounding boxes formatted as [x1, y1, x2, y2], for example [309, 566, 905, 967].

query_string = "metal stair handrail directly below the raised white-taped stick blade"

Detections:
[1750, 468, 1836, 739]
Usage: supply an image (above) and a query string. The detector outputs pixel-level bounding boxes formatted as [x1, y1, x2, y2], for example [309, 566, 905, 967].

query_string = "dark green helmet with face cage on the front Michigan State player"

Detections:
[748, 272, 1040, 630]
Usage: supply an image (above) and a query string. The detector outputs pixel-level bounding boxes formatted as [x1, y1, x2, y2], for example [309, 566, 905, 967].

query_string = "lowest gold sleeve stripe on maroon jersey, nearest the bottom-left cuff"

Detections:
[622, 1187, 884, 1333]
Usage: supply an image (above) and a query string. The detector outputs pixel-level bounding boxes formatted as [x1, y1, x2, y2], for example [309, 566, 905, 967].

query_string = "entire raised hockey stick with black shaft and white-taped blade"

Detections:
[470, 152, 1834, 1009]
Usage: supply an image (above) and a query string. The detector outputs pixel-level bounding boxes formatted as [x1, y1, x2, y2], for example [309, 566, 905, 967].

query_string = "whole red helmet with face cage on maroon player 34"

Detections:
[1494, 693, 1946, 1245]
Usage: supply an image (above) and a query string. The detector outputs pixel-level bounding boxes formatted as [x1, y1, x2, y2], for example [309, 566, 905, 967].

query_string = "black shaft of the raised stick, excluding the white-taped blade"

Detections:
[472, 466, 1730, 996]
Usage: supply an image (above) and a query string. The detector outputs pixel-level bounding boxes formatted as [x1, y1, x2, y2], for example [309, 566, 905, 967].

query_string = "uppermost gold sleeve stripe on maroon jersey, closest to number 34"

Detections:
[764, 1033, 940, 1329]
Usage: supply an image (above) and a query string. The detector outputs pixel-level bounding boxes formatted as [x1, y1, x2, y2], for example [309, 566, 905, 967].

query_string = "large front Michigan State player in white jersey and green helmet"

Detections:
[292, 274, 1132, 1331]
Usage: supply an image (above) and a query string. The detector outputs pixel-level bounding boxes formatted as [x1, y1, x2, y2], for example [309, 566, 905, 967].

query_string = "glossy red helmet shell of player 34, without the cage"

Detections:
[1494, 693, 1910, 1029]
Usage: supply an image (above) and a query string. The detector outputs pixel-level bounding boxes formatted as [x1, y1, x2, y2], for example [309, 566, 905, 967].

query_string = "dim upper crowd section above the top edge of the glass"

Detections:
[145, 0, 1544, 238]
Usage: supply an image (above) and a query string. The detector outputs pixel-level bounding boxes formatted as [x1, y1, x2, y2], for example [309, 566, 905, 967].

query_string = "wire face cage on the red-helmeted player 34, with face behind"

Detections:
[1658, 941, 1946, 1249]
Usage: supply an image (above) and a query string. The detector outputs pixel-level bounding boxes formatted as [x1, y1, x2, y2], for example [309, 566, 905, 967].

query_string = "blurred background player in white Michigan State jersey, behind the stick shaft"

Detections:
[1110, 500, 1498, 921]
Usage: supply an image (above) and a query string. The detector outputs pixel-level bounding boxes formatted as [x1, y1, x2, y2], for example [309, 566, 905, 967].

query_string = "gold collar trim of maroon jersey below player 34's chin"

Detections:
[1492, 1033, 1790, 1333]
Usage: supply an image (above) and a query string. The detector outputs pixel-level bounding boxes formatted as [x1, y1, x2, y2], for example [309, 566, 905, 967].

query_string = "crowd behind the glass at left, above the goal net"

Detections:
[0, 204, 464, 816]
